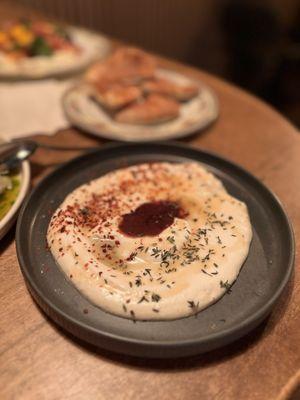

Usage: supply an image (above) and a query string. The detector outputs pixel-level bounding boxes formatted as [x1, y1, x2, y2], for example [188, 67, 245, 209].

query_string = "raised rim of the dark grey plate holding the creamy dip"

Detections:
[16, 142, 295, 358]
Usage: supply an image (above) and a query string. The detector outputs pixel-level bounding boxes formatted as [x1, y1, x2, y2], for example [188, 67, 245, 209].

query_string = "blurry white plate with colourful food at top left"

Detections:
[0, 27, 110, 79]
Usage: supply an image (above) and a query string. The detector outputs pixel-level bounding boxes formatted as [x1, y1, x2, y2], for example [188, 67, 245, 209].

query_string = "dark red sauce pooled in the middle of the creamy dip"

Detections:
[119, 201, 185, 237]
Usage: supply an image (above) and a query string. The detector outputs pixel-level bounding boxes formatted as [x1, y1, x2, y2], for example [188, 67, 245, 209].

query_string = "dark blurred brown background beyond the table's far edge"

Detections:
[10, 0, 300, 126]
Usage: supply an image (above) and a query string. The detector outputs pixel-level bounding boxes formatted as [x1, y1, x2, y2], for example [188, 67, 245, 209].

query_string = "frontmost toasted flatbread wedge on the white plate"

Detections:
[115, 94, 180, 125]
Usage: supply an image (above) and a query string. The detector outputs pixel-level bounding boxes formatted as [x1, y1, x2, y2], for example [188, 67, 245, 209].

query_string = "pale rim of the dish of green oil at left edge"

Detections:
[0, 161, 30, 239]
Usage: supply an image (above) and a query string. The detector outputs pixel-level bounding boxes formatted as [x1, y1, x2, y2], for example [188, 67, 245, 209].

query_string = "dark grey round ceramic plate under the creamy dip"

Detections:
[16, 143, 294, 357]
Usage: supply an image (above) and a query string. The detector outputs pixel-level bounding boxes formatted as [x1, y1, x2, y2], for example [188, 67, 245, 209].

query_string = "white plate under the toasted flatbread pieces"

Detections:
[63, 69, 219, 142]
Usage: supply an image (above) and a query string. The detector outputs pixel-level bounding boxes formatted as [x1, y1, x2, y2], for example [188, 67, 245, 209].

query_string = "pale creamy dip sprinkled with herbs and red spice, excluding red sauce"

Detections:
[47, 163, 252, 320]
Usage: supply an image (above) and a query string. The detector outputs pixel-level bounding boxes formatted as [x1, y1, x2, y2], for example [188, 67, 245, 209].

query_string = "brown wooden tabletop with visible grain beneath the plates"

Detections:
[0, 3, 300, 400]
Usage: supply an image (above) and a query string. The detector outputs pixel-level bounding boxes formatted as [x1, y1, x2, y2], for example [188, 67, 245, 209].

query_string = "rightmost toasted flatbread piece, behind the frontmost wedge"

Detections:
[142, 78, 199, 101]
